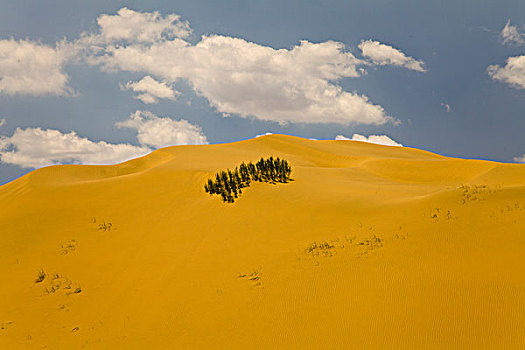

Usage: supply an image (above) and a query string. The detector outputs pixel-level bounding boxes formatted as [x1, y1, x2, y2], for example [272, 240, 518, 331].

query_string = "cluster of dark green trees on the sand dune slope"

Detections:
[204, 157, 292, 203]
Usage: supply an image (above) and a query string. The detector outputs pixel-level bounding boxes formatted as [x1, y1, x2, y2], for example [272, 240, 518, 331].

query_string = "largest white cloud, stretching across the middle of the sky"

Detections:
[69, 8, 394, 125]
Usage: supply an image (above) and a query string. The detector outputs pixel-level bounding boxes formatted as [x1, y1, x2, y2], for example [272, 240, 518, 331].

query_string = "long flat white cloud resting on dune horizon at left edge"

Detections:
[0, 128, 150, 168]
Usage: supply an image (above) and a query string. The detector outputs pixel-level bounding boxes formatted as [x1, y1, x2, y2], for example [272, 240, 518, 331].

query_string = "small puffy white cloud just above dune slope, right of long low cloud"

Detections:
[116, 111, 208, 148]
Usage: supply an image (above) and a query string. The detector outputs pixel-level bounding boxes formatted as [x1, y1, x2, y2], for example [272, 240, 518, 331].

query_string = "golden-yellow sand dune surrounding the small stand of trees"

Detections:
[0, 135, 525, 349]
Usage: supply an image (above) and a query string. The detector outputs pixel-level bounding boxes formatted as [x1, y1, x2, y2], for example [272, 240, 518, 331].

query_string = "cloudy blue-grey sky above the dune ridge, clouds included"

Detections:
[0, 0, 525, 183]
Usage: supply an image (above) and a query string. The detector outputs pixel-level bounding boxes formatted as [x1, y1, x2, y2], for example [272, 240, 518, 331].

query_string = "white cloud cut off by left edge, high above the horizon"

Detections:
[0, 39, 73, 95]
